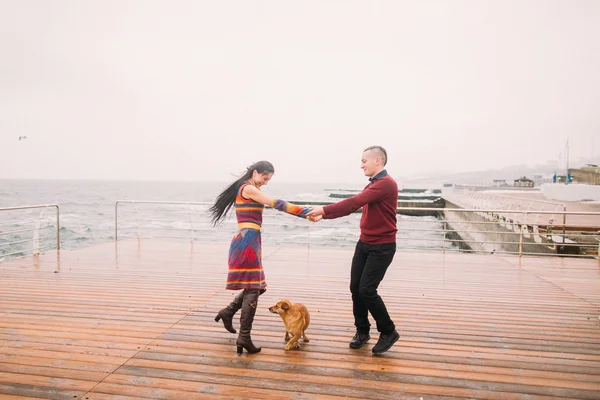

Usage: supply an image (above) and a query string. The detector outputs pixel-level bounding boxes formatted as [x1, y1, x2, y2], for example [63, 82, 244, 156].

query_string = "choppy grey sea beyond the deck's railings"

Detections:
[0, 180, 448, 258]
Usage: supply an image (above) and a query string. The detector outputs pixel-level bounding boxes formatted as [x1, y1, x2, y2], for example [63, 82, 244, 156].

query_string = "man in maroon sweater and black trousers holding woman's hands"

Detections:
[307, 146, 400, 355]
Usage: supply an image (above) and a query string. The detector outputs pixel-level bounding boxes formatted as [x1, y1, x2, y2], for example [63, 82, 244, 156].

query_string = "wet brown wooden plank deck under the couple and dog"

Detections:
[0, 240, 600, 400]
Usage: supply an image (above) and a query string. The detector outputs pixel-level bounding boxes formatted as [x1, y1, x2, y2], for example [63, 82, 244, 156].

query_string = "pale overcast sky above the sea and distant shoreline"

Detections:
[0, 0, 600, 182]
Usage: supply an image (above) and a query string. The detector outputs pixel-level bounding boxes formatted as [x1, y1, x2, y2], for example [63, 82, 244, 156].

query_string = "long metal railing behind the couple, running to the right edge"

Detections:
[115, 200, 600, 257]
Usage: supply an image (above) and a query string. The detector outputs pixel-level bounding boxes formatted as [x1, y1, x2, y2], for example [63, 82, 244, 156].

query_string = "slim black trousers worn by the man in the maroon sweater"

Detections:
[350, 240, 396, 333]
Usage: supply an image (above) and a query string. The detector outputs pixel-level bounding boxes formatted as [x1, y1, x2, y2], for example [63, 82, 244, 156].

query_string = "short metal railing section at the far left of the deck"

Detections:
[0, 204, 60, 259]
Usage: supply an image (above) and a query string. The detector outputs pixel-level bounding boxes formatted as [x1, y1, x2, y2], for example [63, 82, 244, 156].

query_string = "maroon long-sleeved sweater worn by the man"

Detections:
[323, 173, 398, 244]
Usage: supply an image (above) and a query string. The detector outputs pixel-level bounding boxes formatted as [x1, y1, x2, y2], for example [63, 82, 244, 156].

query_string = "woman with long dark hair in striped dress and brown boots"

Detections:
[210, 161, 310, 354]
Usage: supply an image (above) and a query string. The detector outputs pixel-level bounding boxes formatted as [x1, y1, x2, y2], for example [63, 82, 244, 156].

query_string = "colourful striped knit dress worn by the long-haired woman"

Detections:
[226, 181, 310, 290]
